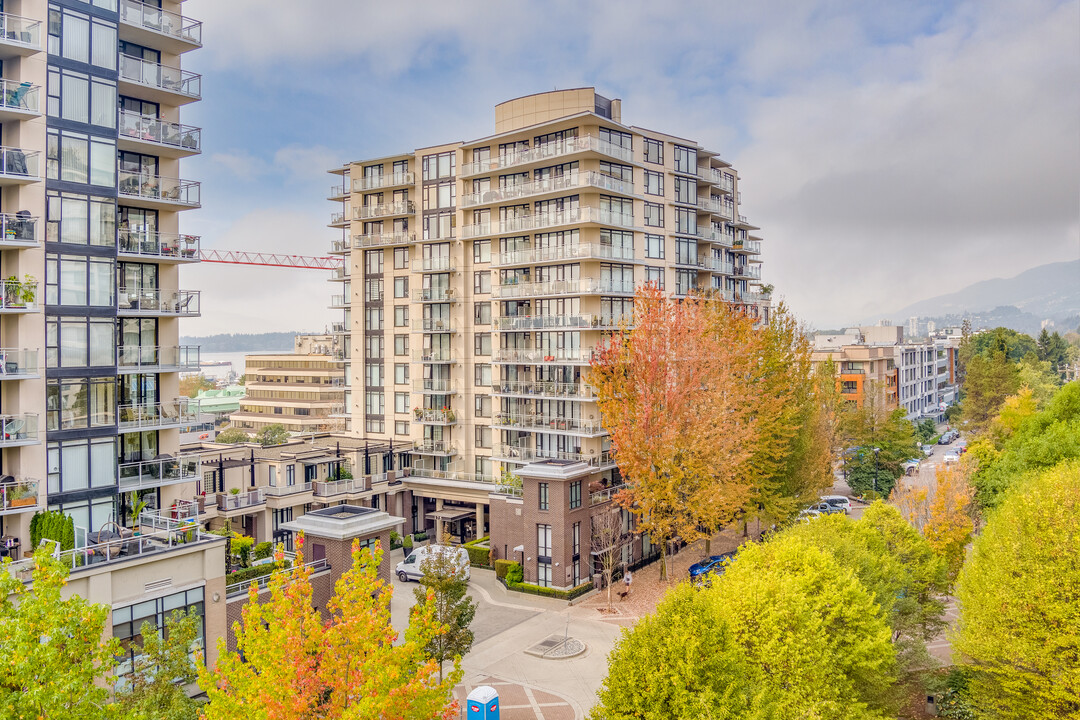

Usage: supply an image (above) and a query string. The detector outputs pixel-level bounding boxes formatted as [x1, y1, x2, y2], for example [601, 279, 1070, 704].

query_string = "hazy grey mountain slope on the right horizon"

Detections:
[866, 260, 1080, 331]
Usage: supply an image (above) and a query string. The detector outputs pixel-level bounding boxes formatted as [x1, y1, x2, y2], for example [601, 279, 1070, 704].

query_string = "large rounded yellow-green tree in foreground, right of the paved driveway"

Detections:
[592, 534, 895, 720]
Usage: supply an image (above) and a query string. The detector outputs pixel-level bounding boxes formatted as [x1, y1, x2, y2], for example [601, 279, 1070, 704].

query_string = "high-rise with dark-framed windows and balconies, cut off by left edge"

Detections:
[0, 0, 202, 554]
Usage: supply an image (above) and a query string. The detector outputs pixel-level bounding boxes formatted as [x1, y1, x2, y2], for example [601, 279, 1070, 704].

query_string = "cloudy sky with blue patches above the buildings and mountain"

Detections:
[180, 0, 1080, 336]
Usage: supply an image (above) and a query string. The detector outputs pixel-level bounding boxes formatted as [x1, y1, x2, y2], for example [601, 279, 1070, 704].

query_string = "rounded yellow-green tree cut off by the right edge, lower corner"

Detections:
[953, 461, 1080, 720]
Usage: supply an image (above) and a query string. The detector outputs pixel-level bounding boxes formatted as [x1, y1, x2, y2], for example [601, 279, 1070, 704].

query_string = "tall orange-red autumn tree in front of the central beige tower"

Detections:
[589, 284, 760, 578]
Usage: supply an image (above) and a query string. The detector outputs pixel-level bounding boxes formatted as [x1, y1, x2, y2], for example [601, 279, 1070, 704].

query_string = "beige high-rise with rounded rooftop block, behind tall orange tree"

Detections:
[329, 87, 769, 585]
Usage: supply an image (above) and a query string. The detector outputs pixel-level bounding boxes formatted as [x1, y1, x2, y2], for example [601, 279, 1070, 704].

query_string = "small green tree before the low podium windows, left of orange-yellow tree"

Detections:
[116, 608, 202, 720]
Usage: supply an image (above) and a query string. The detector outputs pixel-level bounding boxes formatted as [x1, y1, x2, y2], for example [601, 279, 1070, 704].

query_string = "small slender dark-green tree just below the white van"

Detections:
[413, 553, 476, 682]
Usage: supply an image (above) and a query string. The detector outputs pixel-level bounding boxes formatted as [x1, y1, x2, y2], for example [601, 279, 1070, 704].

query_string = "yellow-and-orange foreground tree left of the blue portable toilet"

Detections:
[199, 535, 461, 720]
